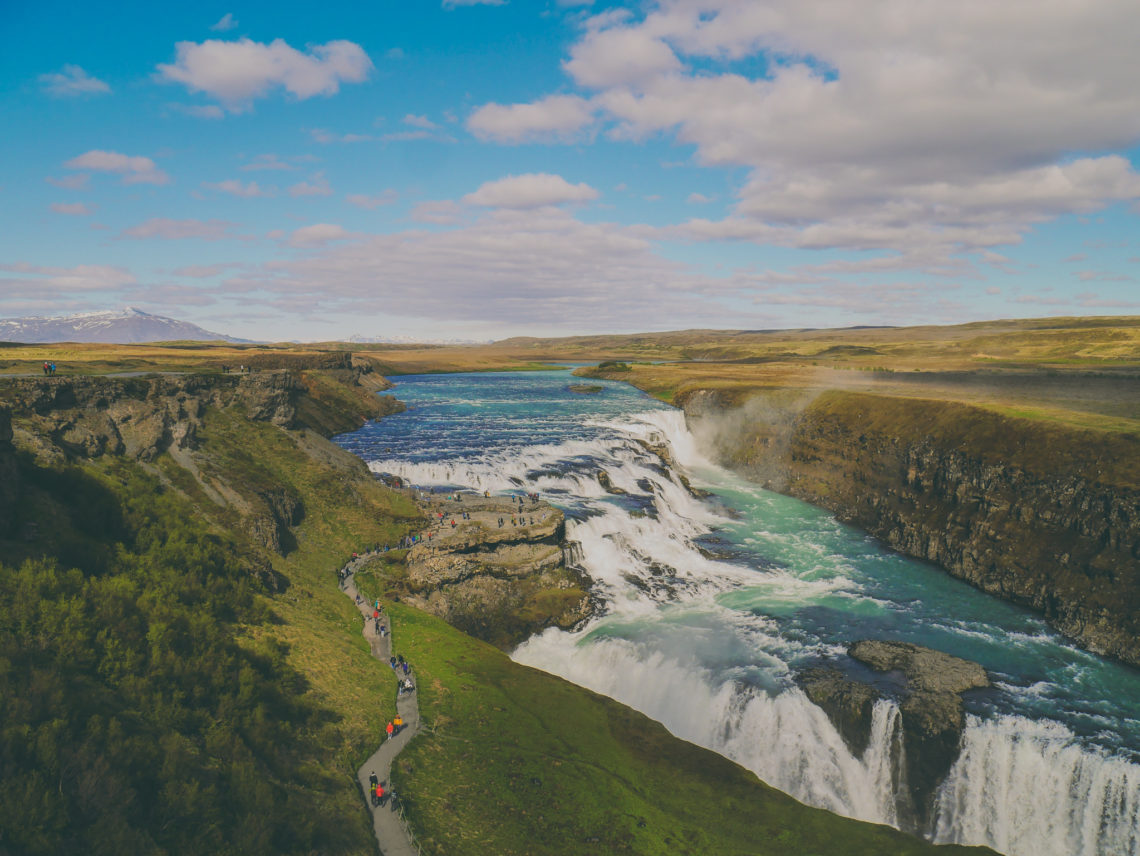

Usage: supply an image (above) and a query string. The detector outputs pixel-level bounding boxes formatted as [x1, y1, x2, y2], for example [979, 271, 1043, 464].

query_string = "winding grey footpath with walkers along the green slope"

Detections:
[341, 555, 420, 856]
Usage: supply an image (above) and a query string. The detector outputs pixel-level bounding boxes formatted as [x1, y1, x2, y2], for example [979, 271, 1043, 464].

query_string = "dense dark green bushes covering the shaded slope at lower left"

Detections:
[0, 459, 361, 854]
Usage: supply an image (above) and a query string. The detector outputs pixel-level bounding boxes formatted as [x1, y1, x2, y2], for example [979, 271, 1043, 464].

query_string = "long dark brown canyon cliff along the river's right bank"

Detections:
[679, 391, 1140, 666]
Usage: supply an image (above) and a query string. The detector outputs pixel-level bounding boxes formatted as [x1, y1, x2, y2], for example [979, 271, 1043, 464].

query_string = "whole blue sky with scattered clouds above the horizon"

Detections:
[0, 0, 1140, 340]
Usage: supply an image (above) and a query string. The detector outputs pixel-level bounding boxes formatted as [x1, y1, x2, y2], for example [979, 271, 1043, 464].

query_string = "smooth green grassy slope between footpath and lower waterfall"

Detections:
[391, 605, 990, 856]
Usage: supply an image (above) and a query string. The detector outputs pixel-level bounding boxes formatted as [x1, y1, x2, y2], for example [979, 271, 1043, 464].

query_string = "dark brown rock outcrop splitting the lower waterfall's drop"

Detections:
[797, 639, 991, 833]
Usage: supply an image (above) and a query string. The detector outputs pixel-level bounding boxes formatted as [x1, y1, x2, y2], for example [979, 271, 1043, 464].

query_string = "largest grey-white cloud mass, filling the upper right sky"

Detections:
[467, 0, 1140, 270]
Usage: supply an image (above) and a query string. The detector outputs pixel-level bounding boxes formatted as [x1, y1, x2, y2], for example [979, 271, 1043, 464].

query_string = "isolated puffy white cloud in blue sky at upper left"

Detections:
[151, 39, 373, 113]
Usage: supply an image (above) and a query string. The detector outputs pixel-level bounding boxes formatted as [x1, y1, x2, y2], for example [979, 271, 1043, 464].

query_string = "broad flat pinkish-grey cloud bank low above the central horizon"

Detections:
[227, 207, 747, 329]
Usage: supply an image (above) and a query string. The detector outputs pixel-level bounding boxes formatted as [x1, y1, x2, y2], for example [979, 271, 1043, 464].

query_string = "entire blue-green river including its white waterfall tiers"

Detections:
[337, 372, 1140, 856]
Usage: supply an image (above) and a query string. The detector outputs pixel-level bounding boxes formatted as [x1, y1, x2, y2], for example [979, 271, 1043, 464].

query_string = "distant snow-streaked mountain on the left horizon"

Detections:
[0, 307, 246, 344]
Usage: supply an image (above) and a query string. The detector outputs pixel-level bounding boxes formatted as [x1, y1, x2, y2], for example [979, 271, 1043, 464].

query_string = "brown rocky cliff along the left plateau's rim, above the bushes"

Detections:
[0, 364, 402, 565]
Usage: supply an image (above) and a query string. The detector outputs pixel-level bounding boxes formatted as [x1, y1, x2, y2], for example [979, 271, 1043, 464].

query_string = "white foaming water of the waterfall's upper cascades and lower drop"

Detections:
[369, 401, 1140, 856]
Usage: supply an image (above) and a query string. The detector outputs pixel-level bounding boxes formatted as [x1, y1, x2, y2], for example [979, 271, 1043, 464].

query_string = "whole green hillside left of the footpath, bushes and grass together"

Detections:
[0, 369, 416, 854]
